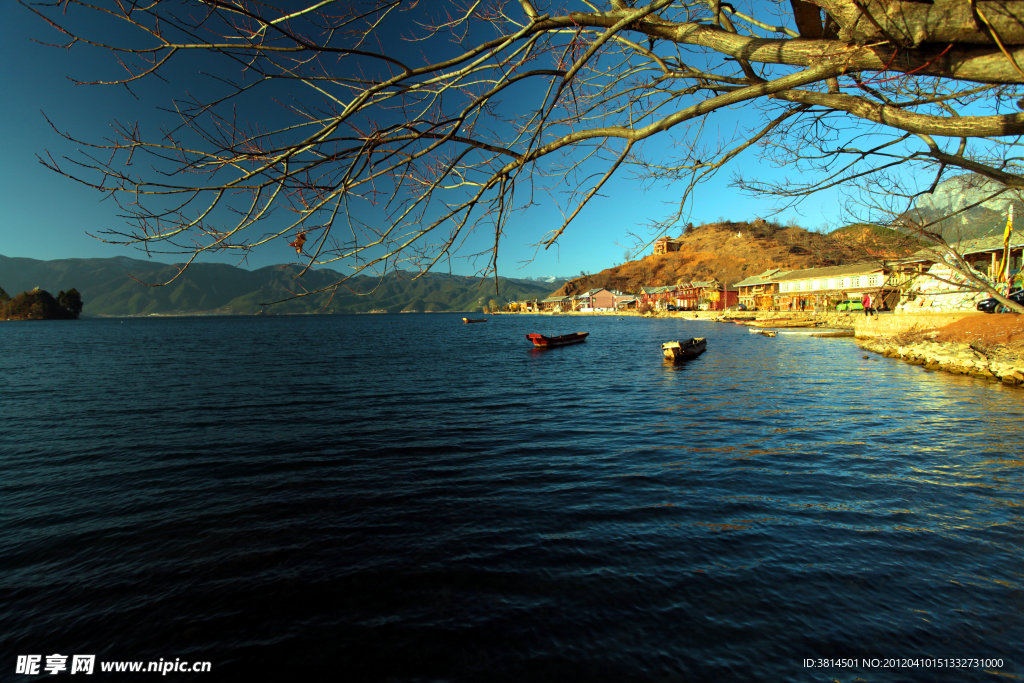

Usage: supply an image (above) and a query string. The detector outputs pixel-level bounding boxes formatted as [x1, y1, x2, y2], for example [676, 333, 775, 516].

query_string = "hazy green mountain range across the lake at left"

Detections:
[0, 256, 564, 316]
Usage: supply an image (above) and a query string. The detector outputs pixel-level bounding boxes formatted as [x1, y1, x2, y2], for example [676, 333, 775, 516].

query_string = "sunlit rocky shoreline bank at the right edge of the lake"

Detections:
[859, 337, 1024, 385]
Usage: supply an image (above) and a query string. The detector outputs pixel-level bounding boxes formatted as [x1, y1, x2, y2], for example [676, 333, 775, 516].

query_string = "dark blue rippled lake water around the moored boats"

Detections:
[0, 314, 1024, 682]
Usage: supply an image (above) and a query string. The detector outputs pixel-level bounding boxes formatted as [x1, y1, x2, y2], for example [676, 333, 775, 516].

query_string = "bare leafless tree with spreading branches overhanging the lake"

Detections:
[19, 0, 1024, 307]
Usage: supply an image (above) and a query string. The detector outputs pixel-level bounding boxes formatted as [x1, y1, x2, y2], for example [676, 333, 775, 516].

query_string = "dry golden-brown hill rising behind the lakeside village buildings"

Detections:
[556, 219, 920, 296]
